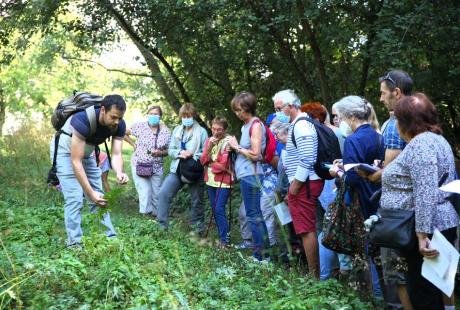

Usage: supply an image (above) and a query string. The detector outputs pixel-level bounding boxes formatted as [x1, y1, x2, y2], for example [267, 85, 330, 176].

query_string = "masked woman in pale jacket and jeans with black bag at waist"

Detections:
[157, 103, 208, 236]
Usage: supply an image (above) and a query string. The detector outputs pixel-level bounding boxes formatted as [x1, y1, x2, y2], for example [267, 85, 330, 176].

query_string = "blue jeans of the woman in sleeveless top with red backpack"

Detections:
[240, 175, 269, 260]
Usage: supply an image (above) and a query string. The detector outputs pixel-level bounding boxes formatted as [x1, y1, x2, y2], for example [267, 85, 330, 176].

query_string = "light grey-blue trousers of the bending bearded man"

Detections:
[56, 152, 116, 245]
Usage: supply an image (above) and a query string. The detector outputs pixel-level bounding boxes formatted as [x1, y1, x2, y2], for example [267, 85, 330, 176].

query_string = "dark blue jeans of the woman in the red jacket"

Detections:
[208, 186, 231, 243]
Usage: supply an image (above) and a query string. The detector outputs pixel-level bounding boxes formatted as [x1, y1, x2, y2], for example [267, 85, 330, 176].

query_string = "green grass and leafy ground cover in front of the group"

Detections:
[0, 124, 375, 309]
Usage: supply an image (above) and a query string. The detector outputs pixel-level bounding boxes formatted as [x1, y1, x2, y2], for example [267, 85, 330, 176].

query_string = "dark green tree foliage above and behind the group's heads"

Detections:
[0, 0, 460, 151]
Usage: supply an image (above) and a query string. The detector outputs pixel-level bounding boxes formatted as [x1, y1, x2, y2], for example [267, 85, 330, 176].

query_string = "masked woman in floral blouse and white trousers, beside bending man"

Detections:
[125, 106, 171, 216]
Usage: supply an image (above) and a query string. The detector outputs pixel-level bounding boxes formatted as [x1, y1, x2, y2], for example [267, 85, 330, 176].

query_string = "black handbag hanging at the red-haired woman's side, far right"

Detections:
[369, 209, 417, 250]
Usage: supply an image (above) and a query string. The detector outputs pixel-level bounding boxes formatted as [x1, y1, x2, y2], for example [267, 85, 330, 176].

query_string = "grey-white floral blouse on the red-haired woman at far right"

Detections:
[380, 132, 459, 234]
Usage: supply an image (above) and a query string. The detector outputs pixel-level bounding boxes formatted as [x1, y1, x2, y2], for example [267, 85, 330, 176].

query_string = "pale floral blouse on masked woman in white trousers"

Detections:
[131, 122, 171, 174]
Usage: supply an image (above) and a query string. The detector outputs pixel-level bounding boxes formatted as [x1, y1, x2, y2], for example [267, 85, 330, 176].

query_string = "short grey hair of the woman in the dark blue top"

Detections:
[332, 96, 372, 121]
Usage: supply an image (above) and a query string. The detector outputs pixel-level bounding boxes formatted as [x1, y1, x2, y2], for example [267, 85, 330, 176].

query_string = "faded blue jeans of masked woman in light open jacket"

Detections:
[157, 173, 204, 234]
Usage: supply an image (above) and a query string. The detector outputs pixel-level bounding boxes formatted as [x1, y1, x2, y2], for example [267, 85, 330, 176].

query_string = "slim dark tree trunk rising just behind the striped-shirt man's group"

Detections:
[297, 0, 331, 108]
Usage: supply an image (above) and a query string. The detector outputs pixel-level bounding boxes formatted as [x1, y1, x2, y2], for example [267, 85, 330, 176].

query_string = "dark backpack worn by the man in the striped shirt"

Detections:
[291, 117, 342, 180]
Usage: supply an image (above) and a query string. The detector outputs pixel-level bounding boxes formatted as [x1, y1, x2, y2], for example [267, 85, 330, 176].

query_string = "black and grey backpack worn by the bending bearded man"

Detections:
[47, 91, 112, 186]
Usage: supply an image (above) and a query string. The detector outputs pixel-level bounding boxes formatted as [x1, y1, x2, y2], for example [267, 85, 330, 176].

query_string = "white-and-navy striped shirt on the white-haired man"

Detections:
[283, 113, 319, 183]
